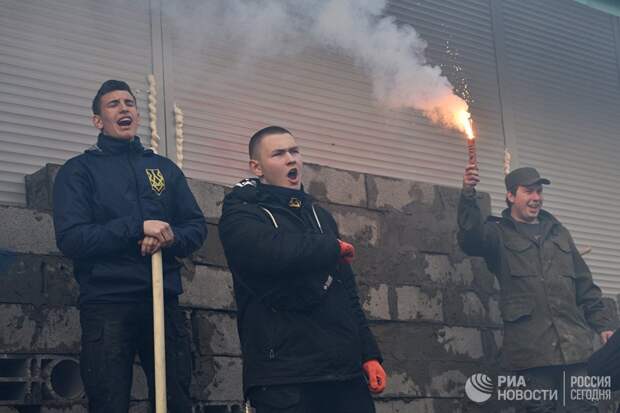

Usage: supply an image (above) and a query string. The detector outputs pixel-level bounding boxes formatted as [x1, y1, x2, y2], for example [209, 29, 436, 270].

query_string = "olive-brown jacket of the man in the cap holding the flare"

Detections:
[458, 191, 615, 370]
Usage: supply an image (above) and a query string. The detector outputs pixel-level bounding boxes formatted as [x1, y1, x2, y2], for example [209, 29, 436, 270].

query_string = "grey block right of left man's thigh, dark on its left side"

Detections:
[192, 311, 241, 356]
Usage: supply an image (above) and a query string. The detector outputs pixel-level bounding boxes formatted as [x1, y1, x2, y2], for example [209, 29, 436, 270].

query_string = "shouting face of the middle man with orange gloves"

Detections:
[250, 133, 303, 189]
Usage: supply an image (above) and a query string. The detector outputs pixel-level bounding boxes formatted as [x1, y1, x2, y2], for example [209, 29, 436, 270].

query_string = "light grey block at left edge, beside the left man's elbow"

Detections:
[0, 206, 60, 254]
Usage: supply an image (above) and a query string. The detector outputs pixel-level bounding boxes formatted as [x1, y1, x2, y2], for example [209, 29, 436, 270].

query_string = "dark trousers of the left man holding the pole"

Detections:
[80, 302, 192, 413]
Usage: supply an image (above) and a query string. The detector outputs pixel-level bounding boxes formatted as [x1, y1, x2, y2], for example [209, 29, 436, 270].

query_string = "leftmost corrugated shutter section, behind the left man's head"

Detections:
[0, 0, 152, 204]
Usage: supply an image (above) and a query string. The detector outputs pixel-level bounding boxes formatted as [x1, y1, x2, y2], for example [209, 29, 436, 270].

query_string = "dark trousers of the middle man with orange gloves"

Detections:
[249, 376, 375, 413]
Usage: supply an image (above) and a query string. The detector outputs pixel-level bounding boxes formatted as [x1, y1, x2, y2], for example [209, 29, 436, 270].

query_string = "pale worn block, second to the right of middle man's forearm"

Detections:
[396, 286, 443, 321]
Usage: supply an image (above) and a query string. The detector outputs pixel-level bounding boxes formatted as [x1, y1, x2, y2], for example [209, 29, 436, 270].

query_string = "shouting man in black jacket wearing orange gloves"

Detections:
[219, 126, 386, 413]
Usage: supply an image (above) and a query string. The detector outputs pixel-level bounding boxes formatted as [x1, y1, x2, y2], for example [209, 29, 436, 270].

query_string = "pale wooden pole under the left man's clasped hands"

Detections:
[151, 250, 167, 413]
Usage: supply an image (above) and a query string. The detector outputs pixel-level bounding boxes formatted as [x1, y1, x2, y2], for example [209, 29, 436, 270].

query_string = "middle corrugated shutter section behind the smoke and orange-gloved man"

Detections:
[164, 0, 504, 204]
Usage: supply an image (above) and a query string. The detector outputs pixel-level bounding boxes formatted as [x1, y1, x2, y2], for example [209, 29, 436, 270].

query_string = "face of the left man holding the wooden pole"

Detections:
[93, 90, 140, 140]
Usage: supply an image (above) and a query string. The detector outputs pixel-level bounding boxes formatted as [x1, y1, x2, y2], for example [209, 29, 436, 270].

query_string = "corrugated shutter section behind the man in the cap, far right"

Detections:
[503, 0, 620, 295]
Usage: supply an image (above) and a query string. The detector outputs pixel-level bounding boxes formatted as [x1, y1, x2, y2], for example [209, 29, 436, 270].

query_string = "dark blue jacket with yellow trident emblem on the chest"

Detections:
[54, 134, 207, 304]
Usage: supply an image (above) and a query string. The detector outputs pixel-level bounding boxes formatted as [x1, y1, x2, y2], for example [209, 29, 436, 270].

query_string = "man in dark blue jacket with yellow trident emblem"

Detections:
[54, 80, 207, 413]
